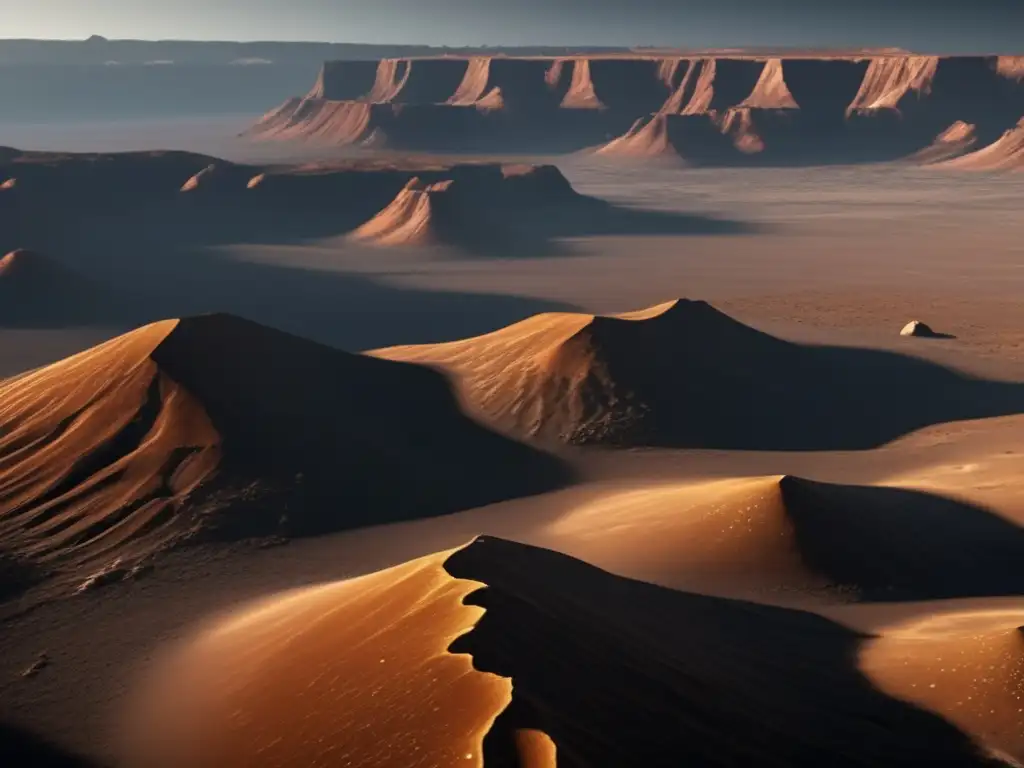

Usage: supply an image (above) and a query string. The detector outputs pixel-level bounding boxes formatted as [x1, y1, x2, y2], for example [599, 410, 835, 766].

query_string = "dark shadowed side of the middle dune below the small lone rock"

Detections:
[563, 300, 1024, 451]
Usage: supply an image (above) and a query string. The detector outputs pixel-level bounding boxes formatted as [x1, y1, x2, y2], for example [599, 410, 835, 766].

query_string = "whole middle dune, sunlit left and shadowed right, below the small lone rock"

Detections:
[374, 300, 1024, 451]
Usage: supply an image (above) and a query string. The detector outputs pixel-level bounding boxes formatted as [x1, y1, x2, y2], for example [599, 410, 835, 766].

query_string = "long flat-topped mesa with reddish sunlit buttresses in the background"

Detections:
[251, 53, 1024, 165]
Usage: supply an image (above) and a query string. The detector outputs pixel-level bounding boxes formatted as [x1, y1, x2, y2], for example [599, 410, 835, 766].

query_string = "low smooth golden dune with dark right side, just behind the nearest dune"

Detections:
[537, 476, 1024, 602]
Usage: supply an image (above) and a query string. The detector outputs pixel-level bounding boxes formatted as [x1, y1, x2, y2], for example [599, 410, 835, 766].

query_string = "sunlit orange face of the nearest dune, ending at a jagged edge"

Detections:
[129, 552, 511, 768]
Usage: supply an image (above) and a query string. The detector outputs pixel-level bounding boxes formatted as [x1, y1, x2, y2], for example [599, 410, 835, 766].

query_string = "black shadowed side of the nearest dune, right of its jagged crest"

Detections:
[444, 538, 1000, 768]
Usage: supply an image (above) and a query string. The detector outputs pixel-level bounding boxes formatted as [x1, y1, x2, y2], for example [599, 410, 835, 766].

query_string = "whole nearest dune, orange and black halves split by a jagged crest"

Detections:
[125, 539, 997, 768]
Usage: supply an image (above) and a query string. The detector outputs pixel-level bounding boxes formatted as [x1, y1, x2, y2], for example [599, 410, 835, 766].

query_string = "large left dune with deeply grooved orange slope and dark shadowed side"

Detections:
[0, 315, 561, 593]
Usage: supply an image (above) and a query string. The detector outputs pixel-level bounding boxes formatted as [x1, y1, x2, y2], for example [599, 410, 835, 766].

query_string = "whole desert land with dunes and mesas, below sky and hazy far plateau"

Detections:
[0, 52, 1024, 768]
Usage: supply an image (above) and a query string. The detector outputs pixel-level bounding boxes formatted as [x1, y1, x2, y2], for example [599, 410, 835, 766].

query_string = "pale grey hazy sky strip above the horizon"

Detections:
[0, 0, 1024, 50]
